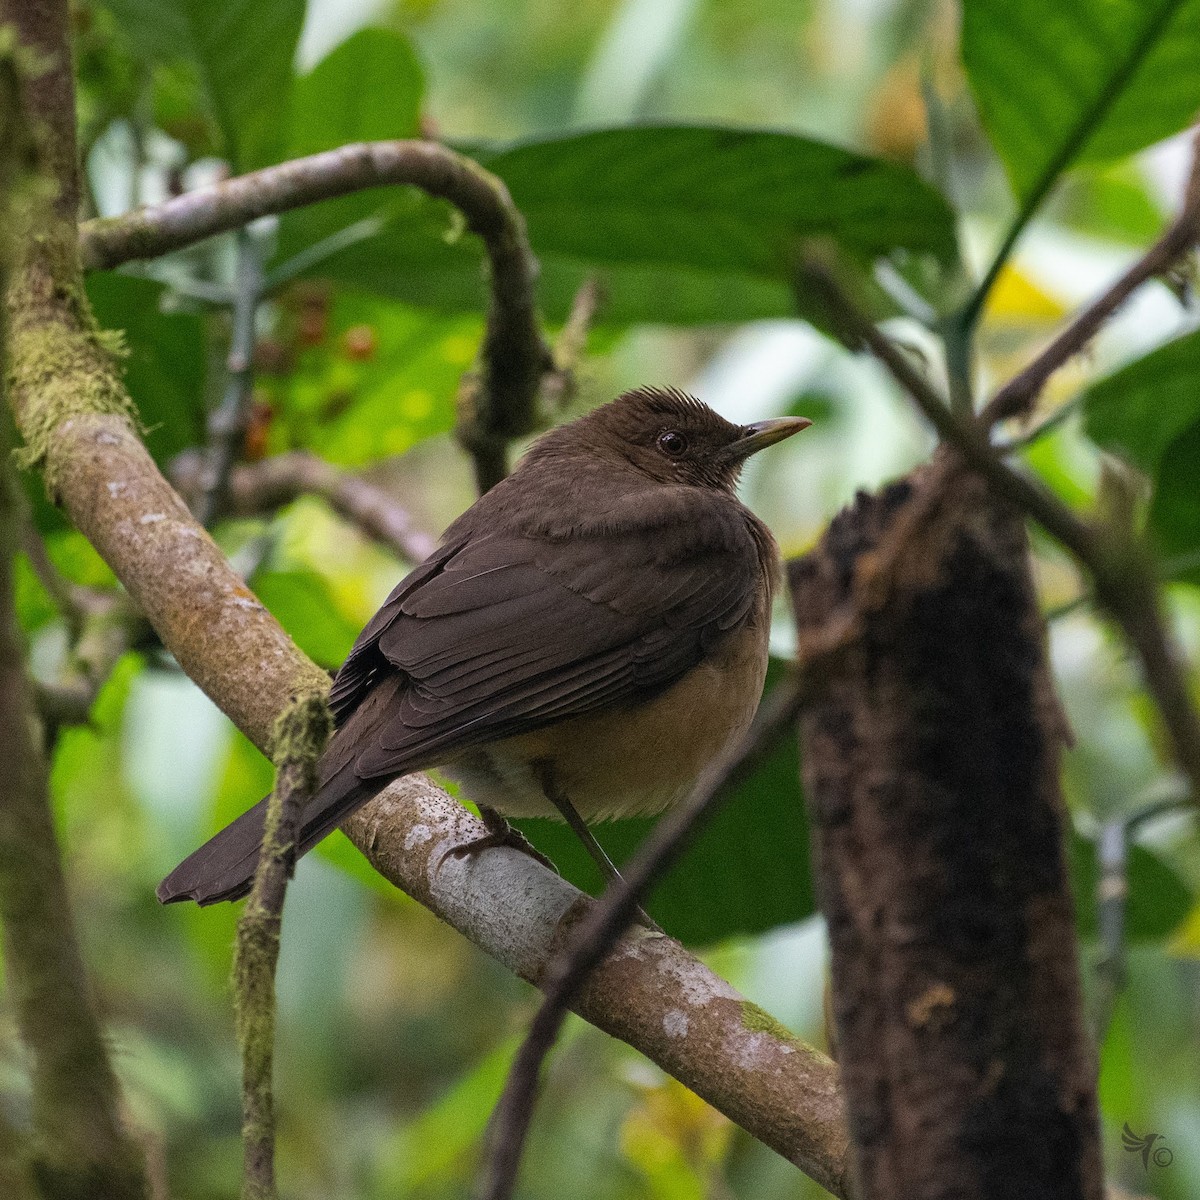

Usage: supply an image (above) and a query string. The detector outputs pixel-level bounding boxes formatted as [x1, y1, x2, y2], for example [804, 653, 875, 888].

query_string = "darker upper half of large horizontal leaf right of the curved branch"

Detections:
[479, 126, 955, 274]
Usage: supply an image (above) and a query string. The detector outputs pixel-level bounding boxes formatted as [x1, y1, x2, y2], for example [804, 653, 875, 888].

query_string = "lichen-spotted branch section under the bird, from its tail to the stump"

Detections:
[343, 775, 848, 1198]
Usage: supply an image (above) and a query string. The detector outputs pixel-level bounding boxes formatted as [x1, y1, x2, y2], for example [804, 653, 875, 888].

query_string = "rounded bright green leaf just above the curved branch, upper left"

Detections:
[289, 29, 425, 157]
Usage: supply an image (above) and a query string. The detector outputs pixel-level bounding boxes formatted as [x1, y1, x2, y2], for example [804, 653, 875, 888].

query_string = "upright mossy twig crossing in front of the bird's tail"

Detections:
[233, 692, 331, 1200]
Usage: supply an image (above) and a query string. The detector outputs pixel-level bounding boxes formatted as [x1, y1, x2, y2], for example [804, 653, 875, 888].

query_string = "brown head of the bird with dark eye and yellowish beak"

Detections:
[544, 388, 812, 492]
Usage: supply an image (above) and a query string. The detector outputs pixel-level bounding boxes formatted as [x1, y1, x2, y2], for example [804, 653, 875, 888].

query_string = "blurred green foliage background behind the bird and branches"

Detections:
[7, 0, 1200, 1200]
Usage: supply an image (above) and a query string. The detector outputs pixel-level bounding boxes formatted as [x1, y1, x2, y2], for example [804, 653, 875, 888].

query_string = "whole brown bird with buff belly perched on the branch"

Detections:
[158, 388, 811, 905]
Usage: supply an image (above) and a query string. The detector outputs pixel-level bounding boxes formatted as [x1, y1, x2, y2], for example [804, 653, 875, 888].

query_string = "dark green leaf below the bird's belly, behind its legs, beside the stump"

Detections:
[514, 662, 815, 946]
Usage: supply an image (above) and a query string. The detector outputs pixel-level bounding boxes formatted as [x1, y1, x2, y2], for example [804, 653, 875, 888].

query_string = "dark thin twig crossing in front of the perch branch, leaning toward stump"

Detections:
[480, 628, 852, 1200]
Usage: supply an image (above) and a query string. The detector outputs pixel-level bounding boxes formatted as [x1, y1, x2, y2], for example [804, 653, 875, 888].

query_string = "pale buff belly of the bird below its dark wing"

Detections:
[442, 622, 767, 822]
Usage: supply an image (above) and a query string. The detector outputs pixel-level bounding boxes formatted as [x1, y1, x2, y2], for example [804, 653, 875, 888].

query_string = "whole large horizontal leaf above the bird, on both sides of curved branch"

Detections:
[272, 126, 955, 323]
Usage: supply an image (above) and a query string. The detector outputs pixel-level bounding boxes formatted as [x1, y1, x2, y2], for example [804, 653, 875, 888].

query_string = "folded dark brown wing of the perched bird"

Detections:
[329, 496, 762, 779]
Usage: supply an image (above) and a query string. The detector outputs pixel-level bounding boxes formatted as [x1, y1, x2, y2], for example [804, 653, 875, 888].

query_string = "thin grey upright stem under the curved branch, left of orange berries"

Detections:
[196, 228, 263, 526]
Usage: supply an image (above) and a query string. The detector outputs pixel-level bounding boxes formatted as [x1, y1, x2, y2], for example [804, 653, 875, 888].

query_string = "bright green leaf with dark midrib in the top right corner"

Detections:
[962, 0, 1200, 204]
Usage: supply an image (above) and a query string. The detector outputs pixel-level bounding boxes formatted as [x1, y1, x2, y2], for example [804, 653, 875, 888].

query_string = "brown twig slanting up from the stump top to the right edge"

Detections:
[982, 133, 1200, 428]
